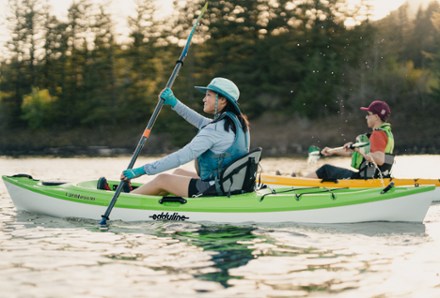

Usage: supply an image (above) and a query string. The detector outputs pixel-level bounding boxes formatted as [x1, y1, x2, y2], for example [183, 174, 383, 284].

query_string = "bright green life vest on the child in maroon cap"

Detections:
[351, 123, 394, 179]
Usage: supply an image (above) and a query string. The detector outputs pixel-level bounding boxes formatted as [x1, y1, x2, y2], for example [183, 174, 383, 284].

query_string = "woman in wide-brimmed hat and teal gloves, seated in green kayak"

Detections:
[103, 78, 249, 197]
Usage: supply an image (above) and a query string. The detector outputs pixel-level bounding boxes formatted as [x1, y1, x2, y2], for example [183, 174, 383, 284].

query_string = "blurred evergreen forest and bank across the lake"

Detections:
[0, 0, 440, 156]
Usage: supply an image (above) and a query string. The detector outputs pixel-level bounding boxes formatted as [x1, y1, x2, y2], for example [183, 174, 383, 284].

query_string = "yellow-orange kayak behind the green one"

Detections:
[261, 174, 440, 202]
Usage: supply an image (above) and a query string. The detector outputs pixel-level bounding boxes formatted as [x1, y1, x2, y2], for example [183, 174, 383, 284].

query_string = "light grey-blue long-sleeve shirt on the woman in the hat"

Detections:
[144, 101, 235, 175]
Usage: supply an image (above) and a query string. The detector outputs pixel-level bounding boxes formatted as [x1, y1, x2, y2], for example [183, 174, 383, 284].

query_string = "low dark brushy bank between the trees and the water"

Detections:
[0, 114, 440, 158]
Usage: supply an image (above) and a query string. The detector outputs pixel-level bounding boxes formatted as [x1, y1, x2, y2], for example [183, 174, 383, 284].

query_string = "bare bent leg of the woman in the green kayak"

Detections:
[131, 173, 192, 197]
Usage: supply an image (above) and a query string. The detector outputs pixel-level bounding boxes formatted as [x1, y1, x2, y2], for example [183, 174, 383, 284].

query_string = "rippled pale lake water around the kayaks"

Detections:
[0, 155, 440, 298]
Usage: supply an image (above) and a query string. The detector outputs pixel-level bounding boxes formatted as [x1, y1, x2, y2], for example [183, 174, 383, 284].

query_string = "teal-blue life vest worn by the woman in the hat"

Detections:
[196, 112, 249, 182]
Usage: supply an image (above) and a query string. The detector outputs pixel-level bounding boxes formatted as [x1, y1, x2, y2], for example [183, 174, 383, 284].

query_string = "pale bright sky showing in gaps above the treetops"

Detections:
[0, 0, 429, 50]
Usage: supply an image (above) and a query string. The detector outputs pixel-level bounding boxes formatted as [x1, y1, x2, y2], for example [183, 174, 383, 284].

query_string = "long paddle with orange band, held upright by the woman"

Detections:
[99, 2, 208, 230]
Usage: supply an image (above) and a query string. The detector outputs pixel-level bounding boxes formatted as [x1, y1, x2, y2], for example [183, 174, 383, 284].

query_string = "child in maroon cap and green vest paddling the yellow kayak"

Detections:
[306, 100, 394, 181]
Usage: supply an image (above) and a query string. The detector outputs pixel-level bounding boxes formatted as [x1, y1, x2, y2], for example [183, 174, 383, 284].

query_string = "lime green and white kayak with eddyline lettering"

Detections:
[3, 176, 434, 223]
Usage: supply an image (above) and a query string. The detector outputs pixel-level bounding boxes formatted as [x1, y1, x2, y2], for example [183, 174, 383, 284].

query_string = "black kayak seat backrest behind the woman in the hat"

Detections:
[220, 147, 263, 196]
